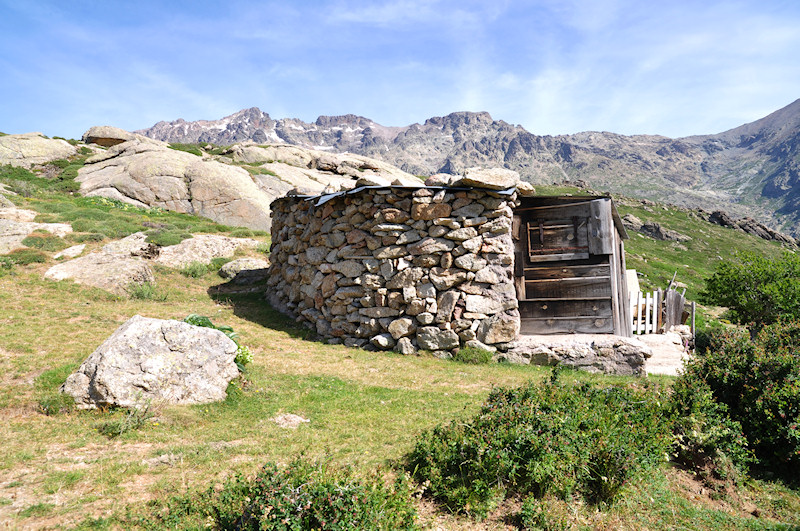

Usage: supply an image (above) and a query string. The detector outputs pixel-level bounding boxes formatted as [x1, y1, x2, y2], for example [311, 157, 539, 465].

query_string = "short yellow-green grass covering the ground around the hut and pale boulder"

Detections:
[0, 178, 800, 529]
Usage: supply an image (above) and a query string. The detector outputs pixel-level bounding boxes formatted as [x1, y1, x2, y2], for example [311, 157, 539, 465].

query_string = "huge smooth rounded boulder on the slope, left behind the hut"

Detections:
[76, 137, 274, 230]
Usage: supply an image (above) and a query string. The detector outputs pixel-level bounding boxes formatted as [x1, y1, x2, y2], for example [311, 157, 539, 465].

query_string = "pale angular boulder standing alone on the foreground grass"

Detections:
[61, 315, 239, 409]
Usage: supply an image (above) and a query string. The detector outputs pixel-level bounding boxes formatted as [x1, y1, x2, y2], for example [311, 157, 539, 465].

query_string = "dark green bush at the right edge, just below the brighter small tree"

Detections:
[676, 321, 800, 479]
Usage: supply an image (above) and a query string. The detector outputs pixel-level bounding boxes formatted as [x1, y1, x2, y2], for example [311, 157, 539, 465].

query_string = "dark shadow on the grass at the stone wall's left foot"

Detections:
[208, 282, 317, 340]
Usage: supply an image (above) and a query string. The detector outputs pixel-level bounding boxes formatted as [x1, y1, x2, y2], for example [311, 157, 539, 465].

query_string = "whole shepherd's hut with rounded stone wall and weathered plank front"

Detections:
[267, 186, 643, 373]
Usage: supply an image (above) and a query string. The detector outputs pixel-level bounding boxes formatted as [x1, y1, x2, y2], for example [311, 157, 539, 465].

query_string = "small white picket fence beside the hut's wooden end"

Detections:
[630, 289, 695, 334]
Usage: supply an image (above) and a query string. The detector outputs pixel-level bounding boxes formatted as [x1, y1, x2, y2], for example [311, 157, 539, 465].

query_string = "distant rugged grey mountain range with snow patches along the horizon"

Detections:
[137, 99, 800, 236]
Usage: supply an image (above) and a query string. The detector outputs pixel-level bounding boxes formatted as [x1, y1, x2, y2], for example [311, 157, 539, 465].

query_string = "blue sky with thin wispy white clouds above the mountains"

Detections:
[0, 0, 800, 138]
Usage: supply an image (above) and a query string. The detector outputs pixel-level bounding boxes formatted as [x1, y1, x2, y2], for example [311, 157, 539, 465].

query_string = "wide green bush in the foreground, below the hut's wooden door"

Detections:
[407, 378, 669, 516]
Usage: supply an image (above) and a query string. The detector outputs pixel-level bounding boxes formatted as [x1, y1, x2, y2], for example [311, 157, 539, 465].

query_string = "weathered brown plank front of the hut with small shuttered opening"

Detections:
[512, 197, 632, 337]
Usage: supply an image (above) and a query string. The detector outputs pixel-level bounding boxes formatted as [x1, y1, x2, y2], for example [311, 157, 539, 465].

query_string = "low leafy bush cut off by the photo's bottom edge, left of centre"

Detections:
[138, 459, 417, 530]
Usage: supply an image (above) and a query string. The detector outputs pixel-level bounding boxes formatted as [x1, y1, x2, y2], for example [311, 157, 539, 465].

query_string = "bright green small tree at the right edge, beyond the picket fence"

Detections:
[700, 252, 800, 327]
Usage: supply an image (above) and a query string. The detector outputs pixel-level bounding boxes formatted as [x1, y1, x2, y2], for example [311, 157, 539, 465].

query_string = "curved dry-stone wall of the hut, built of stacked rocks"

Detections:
[267, 188, 520, 357]
